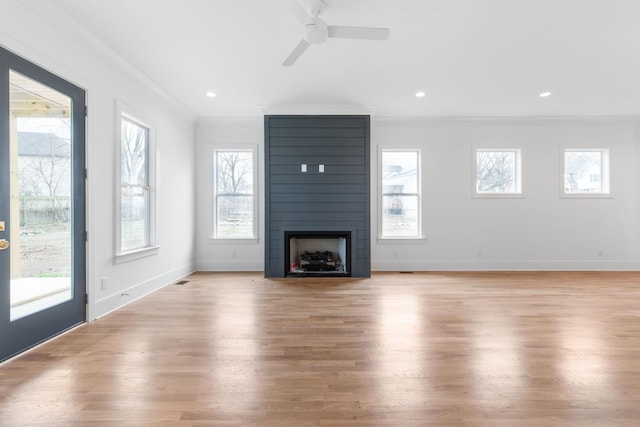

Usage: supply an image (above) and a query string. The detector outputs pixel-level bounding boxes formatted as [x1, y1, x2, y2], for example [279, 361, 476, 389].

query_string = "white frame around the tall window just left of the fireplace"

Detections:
[209, 144, 259, 243]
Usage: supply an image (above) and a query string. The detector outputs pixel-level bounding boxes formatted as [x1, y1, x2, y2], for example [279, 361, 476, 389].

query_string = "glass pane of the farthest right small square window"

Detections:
[564, 151, 604, 193]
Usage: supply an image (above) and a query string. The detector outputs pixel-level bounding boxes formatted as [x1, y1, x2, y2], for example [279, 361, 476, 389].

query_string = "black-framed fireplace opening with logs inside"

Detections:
[284, 231, 351, 277]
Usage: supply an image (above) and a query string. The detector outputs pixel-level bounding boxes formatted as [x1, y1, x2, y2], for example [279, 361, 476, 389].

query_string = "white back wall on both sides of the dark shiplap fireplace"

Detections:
[196, 117, 640, 271]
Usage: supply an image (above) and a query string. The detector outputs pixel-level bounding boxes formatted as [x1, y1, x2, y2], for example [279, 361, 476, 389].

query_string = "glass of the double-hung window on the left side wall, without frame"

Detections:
[120, 119, 149, 252]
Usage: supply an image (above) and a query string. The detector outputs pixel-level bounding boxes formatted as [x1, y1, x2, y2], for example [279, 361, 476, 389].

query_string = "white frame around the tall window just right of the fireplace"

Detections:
[376, 145, 426, 244]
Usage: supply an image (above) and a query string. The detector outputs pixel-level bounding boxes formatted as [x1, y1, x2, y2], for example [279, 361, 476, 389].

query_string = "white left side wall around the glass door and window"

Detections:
[0, 0, 195, 320]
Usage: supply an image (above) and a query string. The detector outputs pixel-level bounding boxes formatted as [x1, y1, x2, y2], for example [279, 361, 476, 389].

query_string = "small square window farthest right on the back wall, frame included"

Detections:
[563, 149, 609, 196]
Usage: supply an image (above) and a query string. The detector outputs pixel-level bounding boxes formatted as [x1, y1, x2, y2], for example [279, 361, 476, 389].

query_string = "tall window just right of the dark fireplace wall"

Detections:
[380, 149, 422, 238]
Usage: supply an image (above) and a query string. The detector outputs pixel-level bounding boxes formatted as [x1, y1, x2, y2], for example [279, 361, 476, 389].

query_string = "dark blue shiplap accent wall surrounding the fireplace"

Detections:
[264, 116, 371, 277]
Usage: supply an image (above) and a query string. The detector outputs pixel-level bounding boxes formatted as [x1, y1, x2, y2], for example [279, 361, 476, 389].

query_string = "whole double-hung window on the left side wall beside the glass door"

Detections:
[116, 104, 155, 261]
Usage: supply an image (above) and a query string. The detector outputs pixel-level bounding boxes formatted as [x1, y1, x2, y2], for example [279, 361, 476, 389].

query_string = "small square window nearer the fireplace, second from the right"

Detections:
[475, 148, 522, 196]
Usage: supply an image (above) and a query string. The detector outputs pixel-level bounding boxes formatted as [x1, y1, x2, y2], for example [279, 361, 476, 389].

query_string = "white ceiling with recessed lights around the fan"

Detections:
[48, 0, 640, 117]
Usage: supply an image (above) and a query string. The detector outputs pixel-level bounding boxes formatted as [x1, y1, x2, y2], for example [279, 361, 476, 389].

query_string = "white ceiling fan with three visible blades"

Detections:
[282, 0, 389, 67]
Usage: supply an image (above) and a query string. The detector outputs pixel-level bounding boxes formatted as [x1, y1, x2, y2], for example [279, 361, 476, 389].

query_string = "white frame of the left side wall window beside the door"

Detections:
[115, 101, 159, 263]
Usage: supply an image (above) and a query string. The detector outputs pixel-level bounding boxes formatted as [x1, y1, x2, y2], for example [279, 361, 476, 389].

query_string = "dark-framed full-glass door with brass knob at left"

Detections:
[0, 48, 86, 361]
